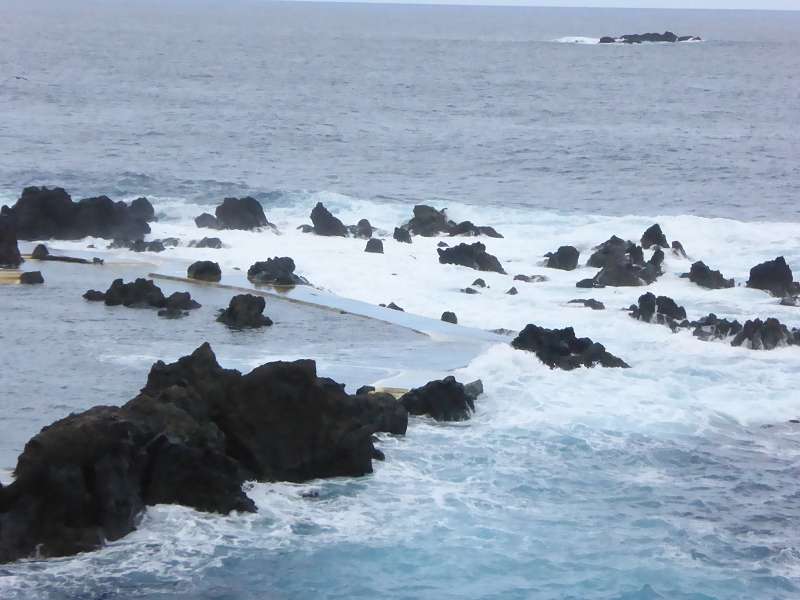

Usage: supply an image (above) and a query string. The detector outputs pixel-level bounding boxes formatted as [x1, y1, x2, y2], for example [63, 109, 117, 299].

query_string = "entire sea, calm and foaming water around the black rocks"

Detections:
[0, 0, 800, 600]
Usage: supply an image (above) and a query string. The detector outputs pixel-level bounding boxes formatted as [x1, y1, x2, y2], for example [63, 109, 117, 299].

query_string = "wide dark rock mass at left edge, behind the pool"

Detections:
[3, 187, 150, 240]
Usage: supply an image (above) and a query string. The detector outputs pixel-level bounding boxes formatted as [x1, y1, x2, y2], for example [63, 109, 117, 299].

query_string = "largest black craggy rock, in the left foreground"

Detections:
[0, 344, 408, 562]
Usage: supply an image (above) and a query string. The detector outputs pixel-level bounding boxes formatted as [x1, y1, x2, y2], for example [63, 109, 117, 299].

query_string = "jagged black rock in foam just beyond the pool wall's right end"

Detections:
[511, 325, 628, 371]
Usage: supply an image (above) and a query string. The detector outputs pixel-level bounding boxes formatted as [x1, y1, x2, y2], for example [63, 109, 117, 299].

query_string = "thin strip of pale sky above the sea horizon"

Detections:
[326, 0, 800, 10]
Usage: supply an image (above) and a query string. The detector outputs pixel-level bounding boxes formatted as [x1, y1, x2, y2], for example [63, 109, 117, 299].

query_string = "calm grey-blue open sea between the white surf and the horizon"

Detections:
[0, 0, 800, 221]
